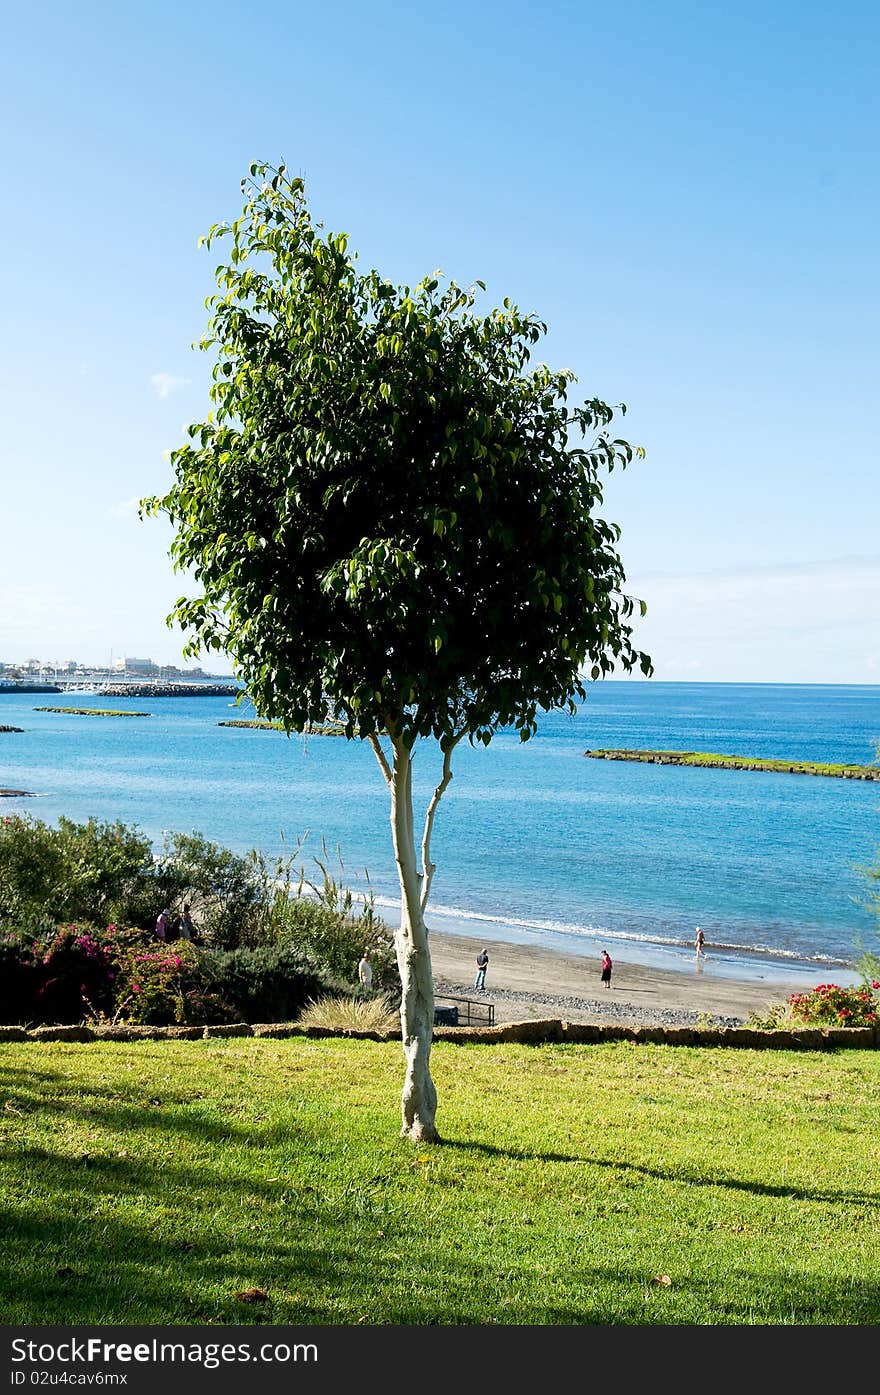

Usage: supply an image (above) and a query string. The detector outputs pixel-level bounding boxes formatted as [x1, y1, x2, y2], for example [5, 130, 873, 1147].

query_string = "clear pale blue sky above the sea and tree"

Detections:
[0, 0, 880, 684]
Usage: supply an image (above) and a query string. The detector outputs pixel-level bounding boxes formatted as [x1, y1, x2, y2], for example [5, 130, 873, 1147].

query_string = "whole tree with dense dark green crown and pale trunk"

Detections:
[144, 165, 651, 1140]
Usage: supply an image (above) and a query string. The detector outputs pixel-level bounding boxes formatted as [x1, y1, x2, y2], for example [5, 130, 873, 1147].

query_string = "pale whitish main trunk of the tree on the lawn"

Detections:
[390, 741, 438, 1143]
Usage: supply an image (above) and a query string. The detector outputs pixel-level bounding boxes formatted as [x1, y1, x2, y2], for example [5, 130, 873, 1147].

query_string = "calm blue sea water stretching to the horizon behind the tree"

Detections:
[0, 681, 880, 982]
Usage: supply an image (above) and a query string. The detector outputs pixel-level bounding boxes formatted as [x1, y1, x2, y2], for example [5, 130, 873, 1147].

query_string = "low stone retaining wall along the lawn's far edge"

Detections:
[0, 1017, 880, 1050]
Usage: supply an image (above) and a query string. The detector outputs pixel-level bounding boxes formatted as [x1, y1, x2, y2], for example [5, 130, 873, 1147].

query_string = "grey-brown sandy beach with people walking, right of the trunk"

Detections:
[430, 930, 821, 1024]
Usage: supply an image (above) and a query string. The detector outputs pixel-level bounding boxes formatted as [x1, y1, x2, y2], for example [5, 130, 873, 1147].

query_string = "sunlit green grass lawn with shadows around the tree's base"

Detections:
[0, 1038, 880, 1324]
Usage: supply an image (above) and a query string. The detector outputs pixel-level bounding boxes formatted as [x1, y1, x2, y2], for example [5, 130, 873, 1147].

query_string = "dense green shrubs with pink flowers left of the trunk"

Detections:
[0, 816, 400, 1024]
